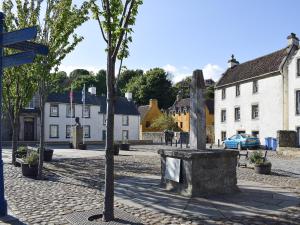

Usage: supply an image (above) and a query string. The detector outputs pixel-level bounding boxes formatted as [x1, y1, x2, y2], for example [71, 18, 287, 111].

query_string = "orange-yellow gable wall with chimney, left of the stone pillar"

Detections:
[140, 99, 162, 132]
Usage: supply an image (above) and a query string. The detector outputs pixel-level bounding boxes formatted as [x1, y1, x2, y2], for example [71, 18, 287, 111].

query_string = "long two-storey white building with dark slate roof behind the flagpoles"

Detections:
[15, 89, 140, 143]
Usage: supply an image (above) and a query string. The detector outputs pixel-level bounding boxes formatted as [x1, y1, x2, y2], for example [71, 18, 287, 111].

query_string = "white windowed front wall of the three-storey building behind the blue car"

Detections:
[215, 75, 283, 144]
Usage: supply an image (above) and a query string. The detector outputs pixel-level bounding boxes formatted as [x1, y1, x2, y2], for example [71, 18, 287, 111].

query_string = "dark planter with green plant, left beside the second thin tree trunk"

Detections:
[21, 152, 39, 178]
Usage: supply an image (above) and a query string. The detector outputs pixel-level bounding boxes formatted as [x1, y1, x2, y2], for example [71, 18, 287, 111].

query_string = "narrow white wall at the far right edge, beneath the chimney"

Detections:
[288, 50, 300, 130]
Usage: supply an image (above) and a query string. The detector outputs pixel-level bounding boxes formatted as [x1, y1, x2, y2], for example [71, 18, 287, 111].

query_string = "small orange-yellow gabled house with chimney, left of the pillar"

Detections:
[138, 99, 162, 132]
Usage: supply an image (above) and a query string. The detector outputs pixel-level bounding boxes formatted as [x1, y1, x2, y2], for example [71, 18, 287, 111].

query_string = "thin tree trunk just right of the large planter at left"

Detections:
[37, 94, 45, 179]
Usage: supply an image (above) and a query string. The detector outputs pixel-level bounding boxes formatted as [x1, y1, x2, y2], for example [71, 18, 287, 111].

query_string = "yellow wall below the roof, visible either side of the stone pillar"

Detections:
[172, 106, 214, 140]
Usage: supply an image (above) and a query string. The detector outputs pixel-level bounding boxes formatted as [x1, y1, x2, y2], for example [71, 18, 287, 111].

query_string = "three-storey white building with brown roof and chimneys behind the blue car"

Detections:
[215, 33, 300, 144]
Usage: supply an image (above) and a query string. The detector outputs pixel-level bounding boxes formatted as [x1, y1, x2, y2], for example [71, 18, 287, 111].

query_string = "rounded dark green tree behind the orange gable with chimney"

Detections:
[126, 68, 175, 108]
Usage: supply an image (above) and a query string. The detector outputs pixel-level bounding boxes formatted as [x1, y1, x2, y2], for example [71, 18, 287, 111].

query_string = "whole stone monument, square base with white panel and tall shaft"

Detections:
[158, 70, 238, 197]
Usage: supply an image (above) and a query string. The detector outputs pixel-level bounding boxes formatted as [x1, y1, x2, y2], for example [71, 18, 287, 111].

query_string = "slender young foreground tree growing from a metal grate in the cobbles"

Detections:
[91, 0, 143, 221]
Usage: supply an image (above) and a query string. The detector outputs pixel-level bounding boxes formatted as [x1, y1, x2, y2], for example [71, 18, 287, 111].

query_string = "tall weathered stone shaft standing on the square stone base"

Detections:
[190, 70, 206, 150]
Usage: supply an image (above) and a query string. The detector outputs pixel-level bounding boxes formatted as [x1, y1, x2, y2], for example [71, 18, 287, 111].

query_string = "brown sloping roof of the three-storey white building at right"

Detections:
[216, 48, 289, 87]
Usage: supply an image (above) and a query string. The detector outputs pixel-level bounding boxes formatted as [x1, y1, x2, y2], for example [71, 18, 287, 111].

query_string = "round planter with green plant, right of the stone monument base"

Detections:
[250, 151, 272, 174]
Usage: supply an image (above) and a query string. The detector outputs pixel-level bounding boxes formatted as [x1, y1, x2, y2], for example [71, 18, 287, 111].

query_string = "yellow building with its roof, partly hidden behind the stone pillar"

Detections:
[169, 97, 214, 142]
